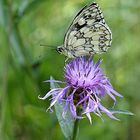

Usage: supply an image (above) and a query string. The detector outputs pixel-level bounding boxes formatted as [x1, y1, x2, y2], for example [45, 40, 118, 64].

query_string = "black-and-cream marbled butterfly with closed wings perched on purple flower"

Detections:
[57, 2, 112, 58]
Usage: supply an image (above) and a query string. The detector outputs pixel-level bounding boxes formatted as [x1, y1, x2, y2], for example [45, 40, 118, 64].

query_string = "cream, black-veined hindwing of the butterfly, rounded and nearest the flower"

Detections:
[68, 22, 111, 57]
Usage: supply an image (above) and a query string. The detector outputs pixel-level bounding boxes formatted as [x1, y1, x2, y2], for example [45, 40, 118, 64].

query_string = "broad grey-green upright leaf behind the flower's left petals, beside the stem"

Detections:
[50, 77, 75, 140]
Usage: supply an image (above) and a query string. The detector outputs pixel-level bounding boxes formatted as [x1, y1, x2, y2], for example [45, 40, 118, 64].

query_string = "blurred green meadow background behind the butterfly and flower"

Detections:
[0, 0, 140, 140]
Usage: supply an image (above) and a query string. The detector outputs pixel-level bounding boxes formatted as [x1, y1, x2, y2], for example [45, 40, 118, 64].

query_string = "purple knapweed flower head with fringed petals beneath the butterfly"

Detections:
[39, 57, 122, 123]
